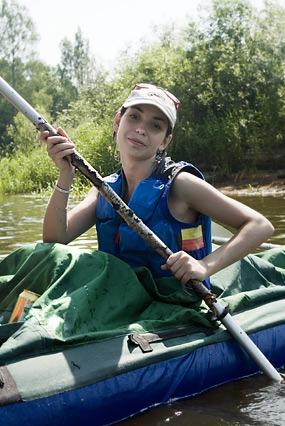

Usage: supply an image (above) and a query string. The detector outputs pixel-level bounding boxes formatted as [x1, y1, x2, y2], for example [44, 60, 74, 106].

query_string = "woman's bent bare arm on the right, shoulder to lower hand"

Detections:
[163, 173, 274, 283]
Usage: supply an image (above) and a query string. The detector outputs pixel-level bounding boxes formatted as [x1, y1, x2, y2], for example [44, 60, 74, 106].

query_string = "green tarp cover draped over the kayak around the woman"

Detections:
[0, 243, 285, 361]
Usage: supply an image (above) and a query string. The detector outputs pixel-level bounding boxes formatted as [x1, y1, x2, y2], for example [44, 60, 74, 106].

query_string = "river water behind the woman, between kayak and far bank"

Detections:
[0, 195, 285, 260]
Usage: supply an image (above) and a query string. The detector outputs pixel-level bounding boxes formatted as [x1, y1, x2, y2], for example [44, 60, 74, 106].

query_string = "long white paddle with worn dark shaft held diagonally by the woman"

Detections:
[0, 77, 283, 382]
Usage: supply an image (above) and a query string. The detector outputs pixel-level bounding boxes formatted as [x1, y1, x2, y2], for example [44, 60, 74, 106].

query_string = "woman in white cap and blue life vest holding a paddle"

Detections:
[40, 84, 274, 287]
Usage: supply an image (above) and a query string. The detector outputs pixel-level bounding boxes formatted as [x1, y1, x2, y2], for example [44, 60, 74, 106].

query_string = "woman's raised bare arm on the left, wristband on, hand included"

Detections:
[40, 128, 98, 244]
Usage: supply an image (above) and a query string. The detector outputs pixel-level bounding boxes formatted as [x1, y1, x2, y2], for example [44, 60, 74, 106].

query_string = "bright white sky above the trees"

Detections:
[18, 0, 285, 69]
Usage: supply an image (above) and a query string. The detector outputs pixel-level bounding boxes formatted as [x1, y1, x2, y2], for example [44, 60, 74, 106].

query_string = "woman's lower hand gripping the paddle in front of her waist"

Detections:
[161, 251, 208, 284]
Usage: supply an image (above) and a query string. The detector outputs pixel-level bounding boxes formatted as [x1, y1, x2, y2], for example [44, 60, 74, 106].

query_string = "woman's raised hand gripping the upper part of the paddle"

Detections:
[40, 127, 75, 176]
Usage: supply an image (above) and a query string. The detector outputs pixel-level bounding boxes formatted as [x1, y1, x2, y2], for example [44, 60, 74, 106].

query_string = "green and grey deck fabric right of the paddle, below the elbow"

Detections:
[211, 246, 285, 333]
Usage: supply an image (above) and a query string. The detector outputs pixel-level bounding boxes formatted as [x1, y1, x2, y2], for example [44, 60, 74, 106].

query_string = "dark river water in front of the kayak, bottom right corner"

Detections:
[120, 375, 285, 426]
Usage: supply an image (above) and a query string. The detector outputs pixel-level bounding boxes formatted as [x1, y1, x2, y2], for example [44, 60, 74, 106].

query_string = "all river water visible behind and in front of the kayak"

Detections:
[0, 195, 285, 426]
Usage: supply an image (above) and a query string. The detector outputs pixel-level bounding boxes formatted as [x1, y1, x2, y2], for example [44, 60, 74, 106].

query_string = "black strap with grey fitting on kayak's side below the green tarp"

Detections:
[128, 325, 214, 353]
